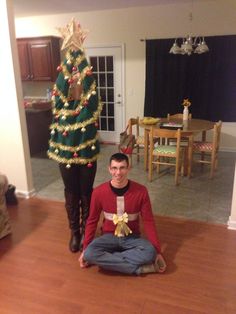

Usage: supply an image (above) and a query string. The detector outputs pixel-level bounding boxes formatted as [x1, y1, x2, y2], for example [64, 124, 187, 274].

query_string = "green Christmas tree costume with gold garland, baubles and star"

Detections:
[48, 19, 102, 168]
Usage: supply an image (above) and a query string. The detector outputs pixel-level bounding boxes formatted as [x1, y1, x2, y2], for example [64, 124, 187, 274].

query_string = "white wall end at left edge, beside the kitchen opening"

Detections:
[0, 0, 33, 196]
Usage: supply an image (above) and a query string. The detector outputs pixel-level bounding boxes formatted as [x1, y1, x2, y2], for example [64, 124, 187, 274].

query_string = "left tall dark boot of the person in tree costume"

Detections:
[65, 191, 81, 253]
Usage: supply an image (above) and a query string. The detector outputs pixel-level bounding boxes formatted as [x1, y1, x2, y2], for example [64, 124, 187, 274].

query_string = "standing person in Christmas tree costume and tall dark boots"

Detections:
[48, 19, 102, 252]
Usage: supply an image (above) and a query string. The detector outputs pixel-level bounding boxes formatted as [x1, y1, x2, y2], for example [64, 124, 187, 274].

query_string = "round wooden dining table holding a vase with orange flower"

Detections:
[139, 118, 215, 170]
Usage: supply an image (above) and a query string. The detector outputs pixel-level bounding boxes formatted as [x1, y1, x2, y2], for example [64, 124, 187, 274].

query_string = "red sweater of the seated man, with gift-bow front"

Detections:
[83, 181, 161, 253]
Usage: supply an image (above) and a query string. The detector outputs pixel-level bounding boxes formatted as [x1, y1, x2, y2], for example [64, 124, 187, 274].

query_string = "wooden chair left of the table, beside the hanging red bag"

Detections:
[128, 117, 144, 166]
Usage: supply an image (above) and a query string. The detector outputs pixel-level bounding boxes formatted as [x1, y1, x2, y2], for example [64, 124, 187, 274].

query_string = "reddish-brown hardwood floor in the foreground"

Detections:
[0, 198, 236, 314]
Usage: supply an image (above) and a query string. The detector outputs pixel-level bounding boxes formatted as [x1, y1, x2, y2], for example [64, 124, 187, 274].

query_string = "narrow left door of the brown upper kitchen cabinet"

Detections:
[18, 41, 31, 81]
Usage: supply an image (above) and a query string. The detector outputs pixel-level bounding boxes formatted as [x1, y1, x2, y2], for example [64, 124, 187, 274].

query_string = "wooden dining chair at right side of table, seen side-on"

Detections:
[193, 121, 222, 179]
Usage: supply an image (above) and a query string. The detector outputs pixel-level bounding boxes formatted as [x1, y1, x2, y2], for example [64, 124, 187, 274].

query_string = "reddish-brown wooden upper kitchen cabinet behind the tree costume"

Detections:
[17, 36, 61, 81]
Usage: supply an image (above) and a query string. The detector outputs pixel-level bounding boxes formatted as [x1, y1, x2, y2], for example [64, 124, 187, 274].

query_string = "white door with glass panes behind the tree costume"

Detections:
[85, 45, 124, 143]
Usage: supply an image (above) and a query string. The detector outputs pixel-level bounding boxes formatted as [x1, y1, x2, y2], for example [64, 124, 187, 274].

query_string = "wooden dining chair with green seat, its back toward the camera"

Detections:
[148, 127, 184, 185]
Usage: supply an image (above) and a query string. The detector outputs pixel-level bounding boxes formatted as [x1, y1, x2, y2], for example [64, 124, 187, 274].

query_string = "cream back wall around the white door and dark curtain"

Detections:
[15, 0, 236, 151]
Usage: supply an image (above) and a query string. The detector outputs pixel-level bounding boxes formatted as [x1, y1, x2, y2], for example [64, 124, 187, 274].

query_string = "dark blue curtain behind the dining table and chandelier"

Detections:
[144, 35, 236, 122]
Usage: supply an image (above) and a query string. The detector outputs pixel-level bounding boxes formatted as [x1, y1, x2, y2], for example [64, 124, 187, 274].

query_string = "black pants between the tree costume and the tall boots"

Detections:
[59, 162, 97, 197]
